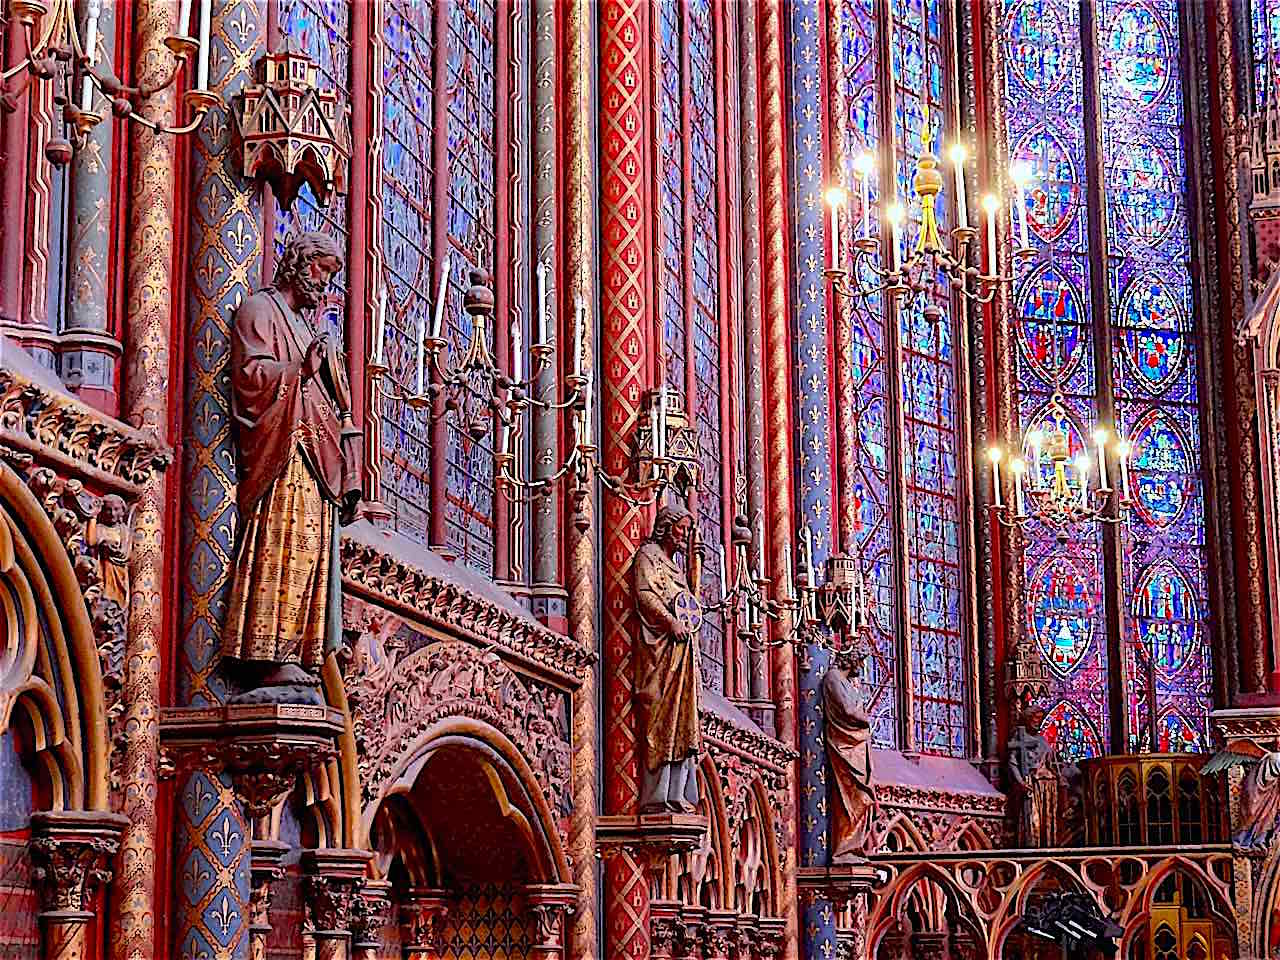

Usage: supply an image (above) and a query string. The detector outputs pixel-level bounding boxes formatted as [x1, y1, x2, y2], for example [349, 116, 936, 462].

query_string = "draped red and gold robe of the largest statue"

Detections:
[223, 288, 349, 673]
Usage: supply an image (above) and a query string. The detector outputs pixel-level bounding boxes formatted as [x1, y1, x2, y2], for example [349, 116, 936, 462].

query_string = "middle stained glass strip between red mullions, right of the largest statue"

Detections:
[381, 0, 435, 541]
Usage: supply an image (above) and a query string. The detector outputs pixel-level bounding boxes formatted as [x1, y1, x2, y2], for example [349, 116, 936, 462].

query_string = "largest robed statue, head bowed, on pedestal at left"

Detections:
[223, 233, 361, 703]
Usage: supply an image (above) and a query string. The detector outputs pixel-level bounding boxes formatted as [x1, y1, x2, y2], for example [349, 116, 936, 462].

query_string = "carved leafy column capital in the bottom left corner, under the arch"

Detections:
[31, 812, 128, 960]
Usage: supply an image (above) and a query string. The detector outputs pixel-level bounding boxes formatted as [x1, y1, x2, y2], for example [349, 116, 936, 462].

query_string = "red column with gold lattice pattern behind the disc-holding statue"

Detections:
[598, 0, 653, 960]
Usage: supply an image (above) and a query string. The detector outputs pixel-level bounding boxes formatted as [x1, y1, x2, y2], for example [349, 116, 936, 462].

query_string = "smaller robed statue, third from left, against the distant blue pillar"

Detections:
[822, 641, 877, 865]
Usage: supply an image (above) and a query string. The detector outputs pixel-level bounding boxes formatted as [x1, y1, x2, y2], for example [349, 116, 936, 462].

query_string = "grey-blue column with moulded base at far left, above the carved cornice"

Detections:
[59, 0, 120, 416]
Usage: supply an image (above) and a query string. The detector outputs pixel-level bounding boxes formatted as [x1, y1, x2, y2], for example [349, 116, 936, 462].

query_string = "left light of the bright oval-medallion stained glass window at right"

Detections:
[1001, 0, 1110, 759]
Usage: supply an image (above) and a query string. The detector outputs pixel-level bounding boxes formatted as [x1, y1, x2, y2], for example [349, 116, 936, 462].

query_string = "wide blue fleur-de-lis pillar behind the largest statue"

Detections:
[174, 0, 266, 960]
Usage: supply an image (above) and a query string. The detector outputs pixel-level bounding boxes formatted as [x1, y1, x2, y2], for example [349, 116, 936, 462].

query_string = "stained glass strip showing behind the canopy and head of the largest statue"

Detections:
[273, 0, 351, 335]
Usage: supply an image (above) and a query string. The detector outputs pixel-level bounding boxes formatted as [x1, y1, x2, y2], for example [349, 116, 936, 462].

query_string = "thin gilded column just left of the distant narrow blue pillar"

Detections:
[759, 0, 798, 960]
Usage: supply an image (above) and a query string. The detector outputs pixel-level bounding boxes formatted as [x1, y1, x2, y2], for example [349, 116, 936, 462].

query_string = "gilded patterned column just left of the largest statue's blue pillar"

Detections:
[110, 0, 177, 960]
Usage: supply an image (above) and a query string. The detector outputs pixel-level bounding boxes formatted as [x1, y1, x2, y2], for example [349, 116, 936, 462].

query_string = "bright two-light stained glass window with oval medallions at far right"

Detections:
[1004, 0, 1211, 758]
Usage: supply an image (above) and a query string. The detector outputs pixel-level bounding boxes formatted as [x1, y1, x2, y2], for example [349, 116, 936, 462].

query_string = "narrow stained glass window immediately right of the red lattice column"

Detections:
[655, 0, 731, 691]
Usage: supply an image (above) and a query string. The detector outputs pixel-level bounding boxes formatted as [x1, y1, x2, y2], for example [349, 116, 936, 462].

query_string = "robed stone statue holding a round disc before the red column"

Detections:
[631, 506, 703, 813]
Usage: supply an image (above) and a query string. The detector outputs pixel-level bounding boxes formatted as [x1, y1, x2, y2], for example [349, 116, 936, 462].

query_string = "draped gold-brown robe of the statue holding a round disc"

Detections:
[634, 543, 701, 772]
